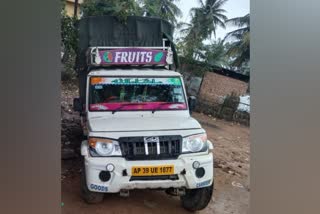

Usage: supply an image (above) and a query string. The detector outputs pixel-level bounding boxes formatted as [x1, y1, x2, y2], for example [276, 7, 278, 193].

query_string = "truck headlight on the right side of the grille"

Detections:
[182, 133, 208, 153]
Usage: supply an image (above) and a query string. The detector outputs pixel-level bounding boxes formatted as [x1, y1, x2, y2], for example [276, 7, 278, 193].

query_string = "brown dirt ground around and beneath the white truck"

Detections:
[61, 86, 250, 214]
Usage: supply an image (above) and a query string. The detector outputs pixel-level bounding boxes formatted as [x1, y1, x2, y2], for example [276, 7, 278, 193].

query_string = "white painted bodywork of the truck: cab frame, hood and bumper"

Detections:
[81, 68, 214, 192]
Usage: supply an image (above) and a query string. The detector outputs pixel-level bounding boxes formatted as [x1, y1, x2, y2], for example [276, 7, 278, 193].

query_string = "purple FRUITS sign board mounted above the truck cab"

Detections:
[88, 39, 173, 67]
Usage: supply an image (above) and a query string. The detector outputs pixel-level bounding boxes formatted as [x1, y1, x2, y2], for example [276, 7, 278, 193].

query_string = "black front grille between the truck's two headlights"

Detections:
[119, 135, 182, 160]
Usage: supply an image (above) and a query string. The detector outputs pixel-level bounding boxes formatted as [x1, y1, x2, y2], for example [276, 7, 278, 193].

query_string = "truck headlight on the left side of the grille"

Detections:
[89, 138, 121, 157]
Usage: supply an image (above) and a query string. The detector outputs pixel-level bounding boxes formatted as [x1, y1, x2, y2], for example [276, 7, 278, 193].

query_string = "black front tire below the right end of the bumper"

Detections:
[180, 183, 213, 211]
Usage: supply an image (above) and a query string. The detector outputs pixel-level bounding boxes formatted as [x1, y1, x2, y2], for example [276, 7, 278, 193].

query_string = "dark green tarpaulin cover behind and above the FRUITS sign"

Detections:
[76, 16, 178, 102]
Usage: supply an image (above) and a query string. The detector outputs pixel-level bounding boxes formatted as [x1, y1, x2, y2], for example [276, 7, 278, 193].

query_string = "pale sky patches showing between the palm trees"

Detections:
[176, 0, 250, 39]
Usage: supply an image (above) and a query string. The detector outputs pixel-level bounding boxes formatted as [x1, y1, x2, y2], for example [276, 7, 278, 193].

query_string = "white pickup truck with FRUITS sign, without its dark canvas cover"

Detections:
[73, 18, 214, 211]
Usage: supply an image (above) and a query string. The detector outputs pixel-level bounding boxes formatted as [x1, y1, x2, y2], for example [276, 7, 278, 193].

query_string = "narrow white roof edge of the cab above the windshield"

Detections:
[88, 68, 181, 76]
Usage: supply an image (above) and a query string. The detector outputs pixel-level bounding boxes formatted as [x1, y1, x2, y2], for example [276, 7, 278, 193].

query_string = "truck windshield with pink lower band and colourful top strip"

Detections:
[89, 77, 187, 111]
